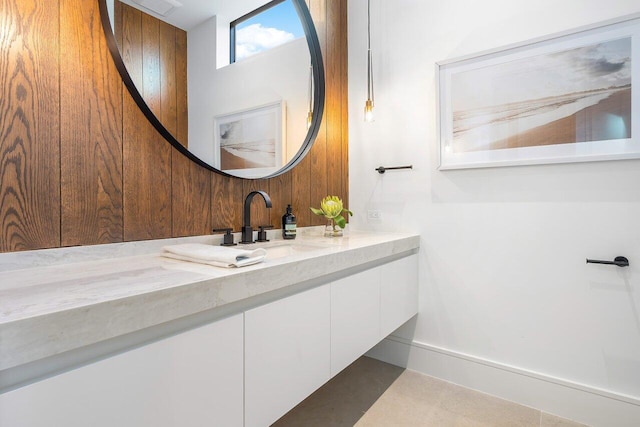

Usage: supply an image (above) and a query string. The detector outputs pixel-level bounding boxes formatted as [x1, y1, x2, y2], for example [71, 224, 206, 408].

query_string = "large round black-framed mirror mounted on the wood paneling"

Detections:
[98, 0, 324, 178]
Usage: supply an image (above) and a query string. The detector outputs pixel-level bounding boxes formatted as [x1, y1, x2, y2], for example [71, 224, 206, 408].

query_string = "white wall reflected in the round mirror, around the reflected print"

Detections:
[187, 17, 311, 164]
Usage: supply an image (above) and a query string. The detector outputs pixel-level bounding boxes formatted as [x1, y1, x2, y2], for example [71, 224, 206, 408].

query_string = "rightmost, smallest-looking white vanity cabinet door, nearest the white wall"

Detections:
[378, 254, 418, 339]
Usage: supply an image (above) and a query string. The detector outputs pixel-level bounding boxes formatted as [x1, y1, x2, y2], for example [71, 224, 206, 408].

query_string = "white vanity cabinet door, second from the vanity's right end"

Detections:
[331, 268, 380, 377]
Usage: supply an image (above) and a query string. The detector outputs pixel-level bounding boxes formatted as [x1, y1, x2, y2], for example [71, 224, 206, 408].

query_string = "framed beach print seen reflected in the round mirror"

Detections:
[214, 101, 286, 178]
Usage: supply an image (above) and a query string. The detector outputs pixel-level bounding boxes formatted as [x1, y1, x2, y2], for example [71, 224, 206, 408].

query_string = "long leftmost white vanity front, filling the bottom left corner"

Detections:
[0, 314, 243, 427]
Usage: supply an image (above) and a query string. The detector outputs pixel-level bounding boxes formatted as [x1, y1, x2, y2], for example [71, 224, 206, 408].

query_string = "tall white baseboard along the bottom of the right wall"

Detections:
[367, 335, 640, 427]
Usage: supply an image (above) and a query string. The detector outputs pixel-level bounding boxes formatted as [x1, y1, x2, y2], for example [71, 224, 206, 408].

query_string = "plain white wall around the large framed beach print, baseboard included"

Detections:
[349, 0, 640, 425]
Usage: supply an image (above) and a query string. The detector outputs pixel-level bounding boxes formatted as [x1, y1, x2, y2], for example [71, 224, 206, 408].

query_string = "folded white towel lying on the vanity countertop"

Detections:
[161, 243, 267, 268]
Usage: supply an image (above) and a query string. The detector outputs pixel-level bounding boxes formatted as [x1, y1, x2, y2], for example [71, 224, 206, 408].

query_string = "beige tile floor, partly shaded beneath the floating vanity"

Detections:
[274, 357, 583, 427]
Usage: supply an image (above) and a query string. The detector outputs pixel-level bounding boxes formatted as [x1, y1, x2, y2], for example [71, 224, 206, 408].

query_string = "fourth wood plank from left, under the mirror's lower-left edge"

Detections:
[171, 149, 212, 237]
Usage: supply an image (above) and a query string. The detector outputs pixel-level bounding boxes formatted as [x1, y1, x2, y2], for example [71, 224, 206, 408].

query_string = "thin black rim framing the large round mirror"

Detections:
[98, 0, 325, 179]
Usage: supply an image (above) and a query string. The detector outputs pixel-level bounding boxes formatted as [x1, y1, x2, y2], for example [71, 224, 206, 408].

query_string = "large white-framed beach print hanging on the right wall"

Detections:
[436, 16, 640, 170]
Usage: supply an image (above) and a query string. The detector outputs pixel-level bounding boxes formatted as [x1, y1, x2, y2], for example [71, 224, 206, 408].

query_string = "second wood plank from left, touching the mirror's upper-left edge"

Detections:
[60, 0, 123, 246]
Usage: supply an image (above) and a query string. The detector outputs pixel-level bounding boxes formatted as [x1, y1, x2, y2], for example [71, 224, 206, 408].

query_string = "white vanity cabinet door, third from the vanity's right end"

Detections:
[245, 285, 330, 427]
